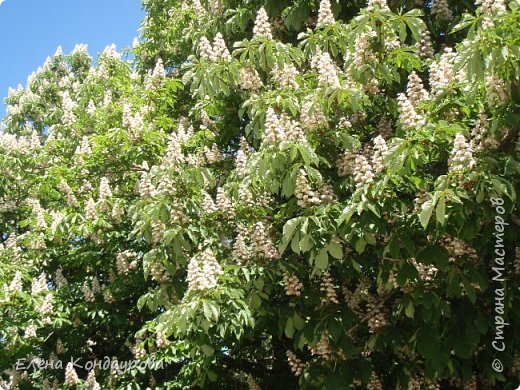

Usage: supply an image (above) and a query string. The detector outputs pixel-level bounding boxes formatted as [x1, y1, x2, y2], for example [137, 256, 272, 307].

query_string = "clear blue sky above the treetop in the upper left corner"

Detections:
[0, 0, 144, 117]
